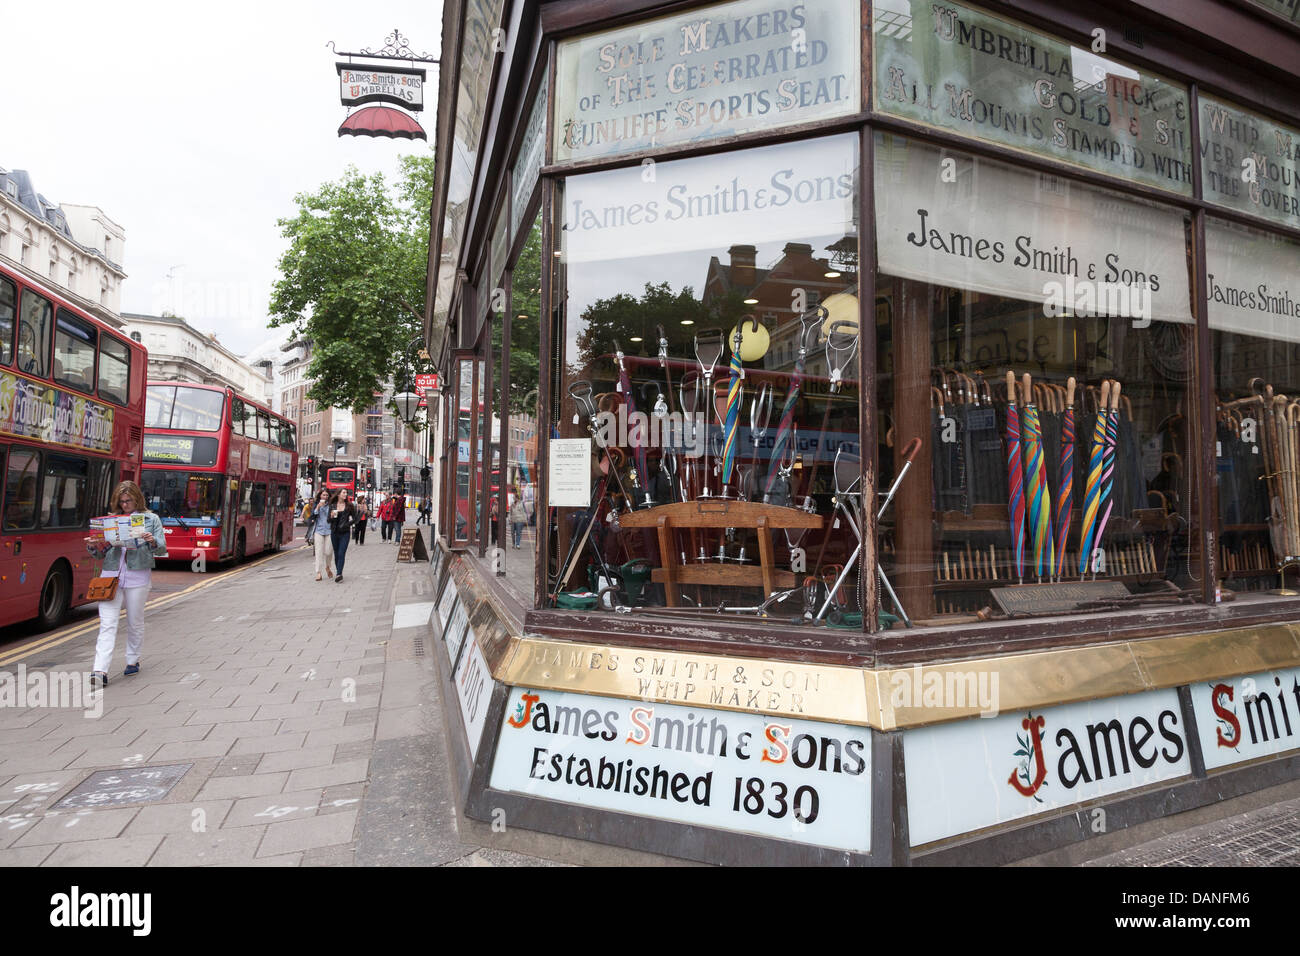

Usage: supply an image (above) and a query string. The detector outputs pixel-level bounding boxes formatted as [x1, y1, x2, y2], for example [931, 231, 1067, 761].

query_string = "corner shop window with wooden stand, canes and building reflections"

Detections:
[547, 134, 870, 628]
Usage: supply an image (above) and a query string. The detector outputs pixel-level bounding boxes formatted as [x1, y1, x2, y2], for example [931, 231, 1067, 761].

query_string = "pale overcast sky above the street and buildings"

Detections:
[0, 0, 442, 354]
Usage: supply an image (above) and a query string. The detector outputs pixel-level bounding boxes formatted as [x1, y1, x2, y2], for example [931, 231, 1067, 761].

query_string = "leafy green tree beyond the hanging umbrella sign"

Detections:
[269, 155, 433, 412]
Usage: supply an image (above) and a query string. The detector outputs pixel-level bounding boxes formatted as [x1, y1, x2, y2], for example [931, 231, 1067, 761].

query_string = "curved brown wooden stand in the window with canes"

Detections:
[619, 498, 823, 607]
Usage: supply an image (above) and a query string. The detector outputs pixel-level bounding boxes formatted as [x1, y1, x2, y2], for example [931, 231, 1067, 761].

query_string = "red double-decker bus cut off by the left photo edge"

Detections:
[0, 265, 148, 627]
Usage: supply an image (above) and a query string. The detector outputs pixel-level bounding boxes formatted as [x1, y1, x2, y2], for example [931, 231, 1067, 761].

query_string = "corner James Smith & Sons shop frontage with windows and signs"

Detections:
[426, 0, 1300, 865]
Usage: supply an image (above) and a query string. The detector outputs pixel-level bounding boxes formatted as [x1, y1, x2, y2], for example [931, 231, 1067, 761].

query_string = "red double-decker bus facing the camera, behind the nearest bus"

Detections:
[140, 382, 298, 567]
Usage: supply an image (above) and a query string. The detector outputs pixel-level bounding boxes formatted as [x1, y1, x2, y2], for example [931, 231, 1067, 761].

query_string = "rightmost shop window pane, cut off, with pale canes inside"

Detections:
[1205, 219, 1300, 600]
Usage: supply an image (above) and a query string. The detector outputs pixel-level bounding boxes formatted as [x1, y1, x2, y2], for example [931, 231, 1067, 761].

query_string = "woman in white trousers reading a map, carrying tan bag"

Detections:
[86, 481, 166, 687]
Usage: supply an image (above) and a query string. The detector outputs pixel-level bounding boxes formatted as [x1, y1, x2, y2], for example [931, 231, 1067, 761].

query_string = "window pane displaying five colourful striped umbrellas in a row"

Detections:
[875, 134, 1200, 626]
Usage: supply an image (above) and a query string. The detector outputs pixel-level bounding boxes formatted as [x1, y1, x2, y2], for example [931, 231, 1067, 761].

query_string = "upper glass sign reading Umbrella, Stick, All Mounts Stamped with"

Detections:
[872, 0, 1192, 195]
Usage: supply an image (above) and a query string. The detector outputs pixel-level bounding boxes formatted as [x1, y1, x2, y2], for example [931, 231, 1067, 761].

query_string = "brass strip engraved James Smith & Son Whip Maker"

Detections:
[494, 637, 868, 726]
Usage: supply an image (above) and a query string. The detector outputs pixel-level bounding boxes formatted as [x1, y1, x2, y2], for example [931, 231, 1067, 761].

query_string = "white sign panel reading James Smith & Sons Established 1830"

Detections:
[491, 687, 871, 853]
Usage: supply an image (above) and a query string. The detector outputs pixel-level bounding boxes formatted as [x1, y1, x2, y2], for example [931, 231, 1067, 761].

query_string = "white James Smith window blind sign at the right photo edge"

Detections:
[1205, 217, 1300, 342]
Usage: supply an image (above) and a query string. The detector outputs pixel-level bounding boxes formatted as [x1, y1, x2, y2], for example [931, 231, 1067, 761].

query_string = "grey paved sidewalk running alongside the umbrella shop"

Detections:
[0, 533, 545, 866]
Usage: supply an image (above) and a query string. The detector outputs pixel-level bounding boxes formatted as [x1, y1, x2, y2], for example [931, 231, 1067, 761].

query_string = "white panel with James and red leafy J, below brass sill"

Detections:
[902, 689, 1192, 847]
